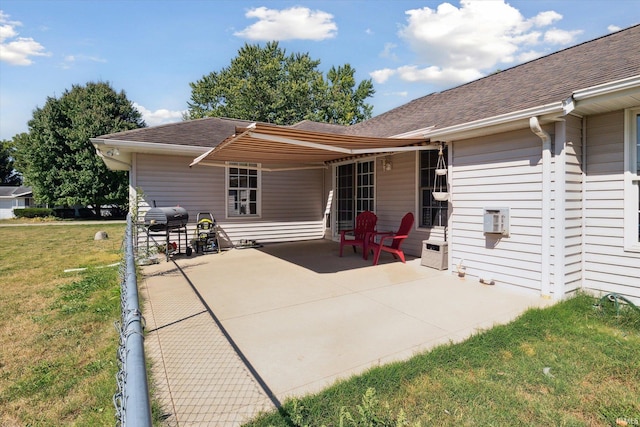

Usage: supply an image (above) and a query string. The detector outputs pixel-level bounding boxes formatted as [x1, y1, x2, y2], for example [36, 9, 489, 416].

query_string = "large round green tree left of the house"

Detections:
[16, 82, 146, 216]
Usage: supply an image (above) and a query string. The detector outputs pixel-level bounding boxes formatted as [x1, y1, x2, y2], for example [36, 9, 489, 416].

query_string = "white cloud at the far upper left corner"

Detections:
[0, 10, 51, 65]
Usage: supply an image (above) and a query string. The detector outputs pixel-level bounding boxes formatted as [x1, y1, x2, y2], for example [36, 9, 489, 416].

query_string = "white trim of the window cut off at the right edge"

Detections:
[624, 108, 640, 252]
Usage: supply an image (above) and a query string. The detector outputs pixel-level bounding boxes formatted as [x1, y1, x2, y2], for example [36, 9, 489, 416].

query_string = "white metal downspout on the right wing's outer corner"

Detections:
[529, 117, 551, 297]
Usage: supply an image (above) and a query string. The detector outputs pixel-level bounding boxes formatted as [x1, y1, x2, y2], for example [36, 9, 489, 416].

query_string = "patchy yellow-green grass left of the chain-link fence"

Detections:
[0, 222, 125, 426]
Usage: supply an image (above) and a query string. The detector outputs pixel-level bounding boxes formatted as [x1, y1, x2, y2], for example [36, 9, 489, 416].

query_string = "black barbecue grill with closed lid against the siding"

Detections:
[144, 206, 191, 261]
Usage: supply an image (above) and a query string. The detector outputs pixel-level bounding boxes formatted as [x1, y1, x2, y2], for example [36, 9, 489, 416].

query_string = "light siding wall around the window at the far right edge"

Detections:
[583, 111, 640, 300]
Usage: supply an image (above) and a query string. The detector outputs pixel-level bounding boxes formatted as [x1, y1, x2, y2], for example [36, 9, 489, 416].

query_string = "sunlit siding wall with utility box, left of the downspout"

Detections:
[449, 129, 542, 291]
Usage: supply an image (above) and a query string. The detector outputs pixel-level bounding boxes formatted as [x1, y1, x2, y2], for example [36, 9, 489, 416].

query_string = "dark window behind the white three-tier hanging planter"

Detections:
[420, 148, 449, 227]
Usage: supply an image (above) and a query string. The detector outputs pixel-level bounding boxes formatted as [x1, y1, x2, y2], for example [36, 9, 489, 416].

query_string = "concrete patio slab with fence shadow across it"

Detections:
[141, 241, 550, 426]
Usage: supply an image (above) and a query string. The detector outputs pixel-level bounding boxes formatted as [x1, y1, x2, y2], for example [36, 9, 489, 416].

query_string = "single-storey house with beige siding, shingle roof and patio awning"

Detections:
[92, 26, 640, 301]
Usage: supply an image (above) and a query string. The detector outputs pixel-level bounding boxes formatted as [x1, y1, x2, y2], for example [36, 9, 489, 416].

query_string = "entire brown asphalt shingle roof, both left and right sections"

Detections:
[98, 25, 640, 147]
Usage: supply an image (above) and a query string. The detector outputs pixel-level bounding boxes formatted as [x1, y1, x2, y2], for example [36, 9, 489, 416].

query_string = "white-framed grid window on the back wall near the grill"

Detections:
[227, 163, 260, 217]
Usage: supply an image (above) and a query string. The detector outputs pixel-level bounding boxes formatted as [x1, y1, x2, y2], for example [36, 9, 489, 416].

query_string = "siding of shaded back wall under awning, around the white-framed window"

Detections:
[132, 154, 324, 243]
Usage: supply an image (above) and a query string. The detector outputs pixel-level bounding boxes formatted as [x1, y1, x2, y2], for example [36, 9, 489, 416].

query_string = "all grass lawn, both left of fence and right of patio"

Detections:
[0, 223, 640, 427]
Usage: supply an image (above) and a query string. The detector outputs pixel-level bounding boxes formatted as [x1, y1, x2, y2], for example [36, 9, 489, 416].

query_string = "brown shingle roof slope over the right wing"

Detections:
[348, 25, 640, 137]
